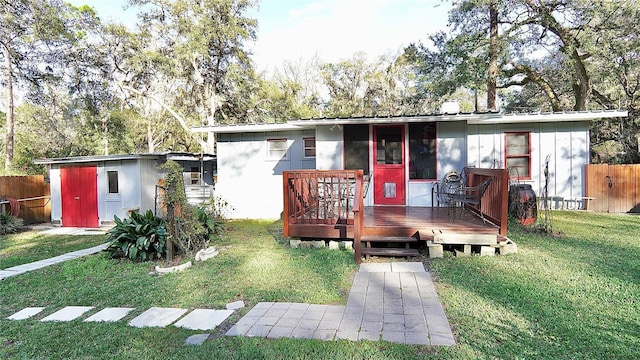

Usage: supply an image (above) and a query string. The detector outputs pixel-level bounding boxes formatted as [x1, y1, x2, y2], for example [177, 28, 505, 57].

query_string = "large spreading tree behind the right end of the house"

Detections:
[405, 0, 640, 162]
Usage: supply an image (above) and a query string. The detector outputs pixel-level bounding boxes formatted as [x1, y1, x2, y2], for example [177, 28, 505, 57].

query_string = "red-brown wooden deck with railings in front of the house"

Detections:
[283, 168, 509, 262]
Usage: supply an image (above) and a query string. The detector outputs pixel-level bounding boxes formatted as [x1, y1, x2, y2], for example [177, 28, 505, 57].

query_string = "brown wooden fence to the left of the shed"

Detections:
[0, 175, 51, 224]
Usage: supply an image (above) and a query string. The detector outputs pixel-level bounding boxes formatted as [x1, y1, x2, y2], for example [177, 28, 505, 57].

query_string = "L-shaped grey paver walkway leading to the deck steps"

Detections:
[227, 262, 455, 345]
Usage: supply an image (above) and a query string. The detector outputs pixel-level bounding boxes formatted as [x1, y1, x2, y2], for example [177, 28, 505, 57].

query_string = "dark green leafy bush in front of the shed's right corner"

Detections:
[105, 210, 167, 261]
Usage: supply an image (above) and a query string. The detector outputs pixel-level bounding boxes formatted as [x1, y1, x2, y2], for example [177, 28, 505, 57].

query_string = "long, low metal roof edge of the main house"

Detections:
[191, 110, 628, 133]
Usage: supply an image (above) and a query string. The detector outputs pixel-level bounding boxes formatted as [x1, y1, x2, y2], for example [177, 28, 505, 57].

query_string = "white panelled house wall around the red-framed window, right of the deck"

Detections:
[467, 122, 590, 198]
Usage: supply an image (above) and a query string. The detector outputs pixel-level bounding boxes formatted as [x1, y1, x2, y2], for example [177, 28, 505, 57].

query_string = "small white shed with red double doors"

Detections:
[34, 152, 216, 228]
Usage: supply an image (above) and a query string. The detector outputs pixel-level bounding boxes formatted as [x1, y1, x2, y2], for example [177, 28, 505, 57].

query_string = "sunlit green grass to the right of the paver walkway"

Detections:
[432, 212, 640, 359]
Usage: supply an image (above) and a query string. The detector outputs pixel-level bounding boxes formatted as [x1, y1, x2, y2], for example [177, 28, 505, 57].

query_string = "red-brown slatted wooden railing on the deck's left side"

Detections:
[282, 170, 364, 237]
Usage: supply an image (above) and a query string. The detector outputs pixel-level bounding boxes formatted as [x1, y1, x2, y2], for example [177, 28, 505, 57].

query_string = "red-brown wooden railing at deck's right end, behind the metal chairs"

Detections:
[465, 168, 509, 236]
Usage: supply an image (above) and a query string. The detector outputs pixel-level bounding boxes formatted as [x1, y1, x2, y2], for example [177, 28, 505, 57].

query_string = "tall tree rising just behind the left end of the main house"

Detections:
[122, 0, 257, 151]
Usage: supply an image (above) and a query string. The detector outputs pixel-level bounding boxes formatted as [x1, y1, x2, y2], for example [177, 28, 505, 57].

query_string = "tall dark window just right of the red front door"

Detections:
[409, 123, 437, 180]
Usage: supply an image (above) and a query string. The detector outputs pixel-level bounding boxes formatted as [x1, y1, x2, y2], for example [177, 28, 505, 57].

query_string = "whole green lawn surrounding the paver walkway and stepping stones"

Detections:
[0, 212, 640, 359]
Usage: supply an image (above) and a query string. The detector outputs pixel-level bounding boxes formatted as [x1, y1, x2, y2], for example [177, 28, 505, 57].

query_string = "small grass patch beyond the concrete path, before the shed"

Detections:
[0, 231, 107, 269]
